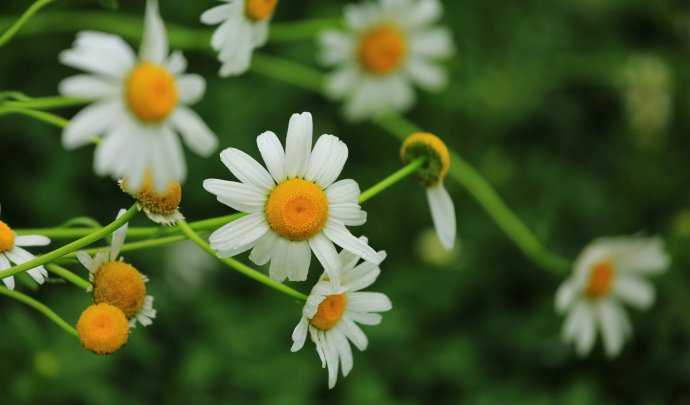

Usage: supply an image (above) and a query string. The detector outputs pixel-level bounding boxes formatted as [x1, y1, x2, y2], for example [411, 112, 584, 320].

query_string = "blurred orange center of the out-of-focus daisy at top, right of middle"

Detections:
[359, 25, 407, 75]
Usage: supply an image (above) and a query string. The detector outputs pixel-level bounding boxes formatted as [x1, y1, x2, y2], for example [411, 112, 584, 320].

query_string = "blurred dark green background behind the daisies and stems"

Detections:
[0, 0, 690, 404]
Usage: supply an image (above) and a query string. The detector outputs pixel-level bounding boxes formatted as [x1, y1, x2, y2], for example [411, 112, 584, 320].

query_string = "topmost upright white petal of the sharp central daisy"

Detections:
[285, 112, 314, 177]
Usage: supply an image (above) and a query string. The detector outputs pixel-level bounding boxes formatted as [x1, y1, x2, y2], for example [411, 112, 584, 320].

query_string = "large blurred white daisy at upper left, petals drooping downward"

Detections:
[60, 0, 218, 191]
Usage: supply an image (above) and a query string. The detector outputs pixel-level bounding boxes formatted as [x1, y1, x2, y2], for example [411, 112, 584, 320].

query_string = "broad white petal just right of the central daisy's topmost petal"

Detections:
[304, 135, 348, 188]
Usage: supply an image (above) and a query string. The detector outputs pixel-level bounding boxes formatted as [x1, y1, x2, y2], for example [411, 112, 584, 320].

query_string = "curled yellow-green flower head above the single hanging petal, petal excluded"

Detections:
[400, 132, 450, 187]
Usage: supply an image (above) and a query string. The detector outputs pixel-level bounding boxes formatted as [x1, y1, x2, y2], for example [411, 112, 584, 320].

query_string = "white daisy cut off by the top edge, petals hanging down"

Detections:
[201, 0, 278, 77]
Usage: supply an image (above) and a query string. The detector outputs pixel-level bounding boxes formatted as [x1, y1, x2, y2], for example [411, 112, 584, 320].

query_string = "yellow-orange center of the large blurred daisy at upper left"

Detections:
[126, 63, 177, 122]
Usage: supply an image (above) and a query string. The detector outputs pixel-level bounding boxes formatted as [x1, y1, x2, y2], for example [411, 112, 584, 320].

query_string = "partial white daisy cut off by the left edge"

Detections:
[0, 221, 50, 290]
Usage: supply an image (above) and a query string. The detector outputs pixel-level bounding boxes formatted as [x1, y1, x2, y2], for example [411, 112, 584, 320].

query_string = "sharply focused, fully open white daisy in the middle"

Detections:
[204, 113, 381, 281]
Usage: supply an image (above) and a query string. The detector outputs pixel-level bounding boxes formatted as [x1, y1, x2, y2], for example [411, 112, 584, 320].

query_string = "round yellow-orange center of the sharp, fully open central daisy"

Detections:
[266, 178, 328, 241]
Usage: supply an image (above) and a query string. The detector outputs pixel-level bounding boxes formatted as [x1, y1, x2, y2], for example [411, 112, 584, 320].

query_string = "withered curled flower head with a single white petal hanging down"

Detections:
[400, 132, 457, 250]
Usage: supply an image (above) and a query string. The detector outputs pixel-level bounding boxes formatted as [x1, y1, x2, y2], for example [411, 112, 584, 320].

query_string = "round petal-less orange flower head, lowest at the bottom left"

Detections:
[77, 304, 129, 354]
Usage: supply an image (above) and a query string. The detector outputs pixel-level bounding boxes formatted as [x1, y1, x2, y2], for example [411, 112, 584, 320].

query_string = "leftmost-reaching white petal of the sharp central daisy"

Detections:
[203, 179, 266, 213]
